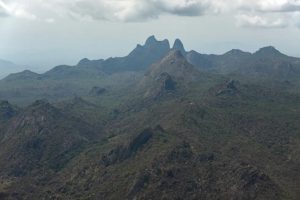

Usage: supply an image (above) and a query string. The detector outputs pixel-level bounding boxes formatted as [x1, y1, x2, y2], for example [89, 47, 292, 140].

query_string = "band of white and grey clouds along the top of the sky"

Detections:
[0, 0, 300, 28]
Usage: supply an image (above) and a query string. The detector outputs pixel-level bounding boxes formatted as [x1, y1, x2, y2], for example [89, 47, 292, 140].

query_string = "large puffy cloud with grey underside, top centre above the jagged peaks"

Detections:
[64, 0, 208, 21]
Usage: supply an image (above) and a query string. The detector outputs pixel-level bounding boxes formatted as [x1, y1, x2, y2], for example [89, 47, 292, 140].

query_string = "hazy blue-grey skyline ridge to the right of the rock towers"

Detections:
[186, 46, 300, 80]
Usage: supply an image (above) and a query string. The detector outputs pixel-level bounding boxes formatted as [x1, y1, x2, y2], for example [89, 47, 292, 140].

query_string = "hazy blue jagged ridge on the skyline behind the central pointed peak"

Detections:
[5, 35, 300, 80]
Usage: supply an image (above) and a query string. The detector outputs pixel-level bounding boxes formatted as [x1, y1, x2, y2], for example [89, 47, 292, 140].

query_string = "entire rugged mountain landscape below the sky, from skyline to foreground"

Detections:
[0, 36, 300, 200]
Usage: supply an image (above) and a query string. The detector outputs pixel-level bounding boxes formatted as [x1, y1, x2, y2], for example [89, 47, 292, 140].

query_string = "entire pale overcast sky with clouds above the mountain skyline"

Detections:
[0, 0, 300, 70]
